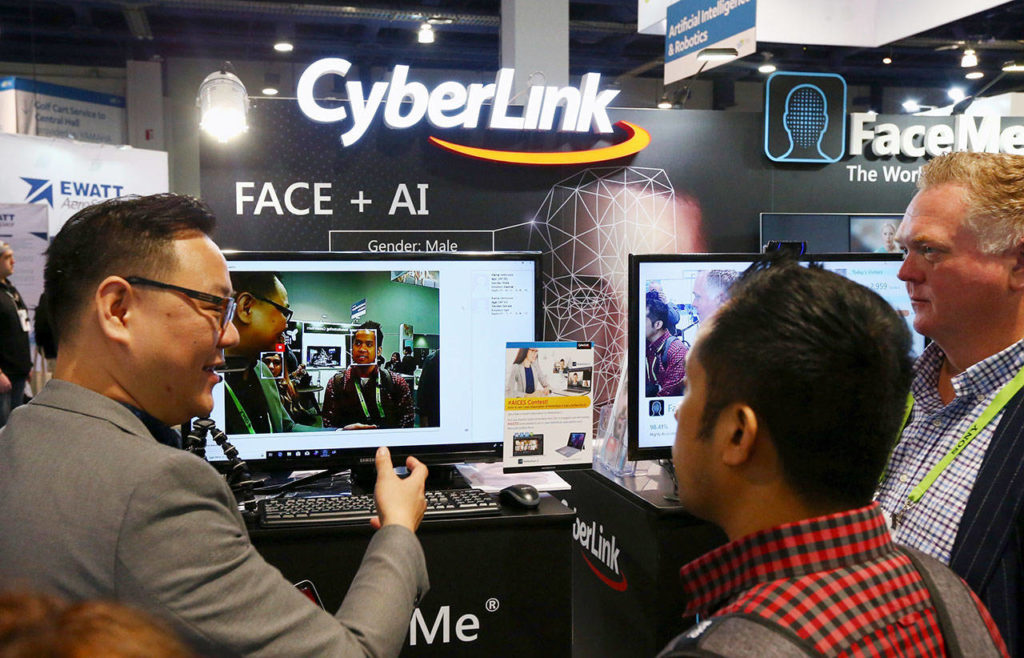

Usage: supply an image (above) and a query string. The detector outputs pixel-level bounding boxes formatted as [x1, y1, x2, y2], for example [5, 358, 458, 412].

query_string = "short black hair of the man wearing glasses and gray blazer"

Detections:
[43, 193, 216, 341]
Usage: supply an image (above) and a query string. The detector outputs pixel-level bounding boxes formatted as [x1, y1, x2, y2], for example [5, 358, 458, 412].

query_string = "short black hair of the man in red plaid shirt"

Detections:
[694, 252, 912, 509]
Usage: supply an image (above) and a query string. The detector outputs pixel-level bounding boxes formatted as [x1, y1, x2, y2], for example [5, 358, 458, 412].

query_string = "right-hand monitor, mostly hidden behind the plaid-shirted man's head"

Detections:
[628, 254, 925, 459]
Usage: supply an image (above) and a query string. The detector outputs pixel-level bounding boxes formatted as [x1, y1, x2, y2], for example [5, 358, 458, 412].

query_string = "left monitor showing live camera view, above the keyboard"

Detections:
[207, 253, 541, 470]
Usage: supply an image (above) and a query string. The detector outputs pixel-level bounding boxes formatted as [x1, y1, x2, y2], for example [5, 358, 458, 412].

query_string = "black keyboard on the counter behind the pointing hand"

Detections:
[259, 489, 501, 527]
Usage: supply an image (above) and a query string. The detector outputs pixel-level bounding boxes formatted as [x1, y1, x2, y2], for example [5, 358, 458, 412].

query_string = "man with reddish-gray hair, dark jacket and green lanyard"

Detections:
[877, 152, 1024, 656]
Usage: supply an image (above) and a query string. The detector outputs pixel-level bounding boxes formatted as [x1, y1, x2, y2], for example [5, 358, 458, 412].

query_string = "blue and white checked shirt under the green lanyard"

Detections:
[876, 341, 1024, 564]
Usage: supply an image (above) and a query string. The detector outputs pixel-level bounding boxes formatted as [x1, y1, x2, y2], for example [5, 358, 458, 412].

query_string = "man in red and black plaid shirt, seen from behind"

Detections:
[660, 252, 1007, 658]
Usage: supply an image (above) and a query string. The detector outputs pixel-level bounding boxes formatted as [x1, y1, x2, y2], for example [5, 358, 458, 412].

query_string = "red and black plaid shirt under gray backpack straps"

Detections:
[681, 503, 1007, 657]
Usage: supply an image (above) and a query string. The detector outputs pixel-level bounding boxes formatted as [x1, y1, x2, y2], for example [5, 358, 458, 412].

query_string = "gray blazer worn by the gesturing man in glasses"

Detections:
[0, 380, 428, 657]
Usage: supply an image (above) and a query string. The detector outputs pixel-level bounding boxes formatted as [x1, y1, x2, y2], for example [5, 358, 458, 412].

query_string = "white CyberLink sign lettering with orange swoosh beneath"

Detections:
[296, 57, 650, 165]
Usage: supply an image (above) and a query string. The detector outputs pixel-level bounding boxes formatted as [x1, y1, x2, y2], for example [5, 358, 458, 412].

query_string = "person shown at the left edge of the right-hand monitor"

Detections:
[644, 290, 687, 397]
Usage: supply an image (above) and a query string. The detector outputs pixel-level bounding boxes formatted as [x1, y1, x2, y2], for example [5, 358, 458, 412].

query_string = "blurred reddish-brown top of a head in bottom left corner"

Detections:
[0, 591, 197, 658]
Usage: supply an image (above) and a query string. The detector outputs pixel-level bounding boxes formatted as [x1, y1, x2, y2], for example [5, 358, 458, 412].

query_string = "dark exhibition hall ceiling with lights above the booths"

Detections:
[0, 0, 1024, 93]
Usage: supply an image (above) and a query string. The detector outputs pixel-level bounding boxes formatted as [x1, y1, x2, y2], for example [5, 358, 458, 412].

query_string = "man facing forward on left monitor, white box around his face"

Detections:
[324, 320, 416, 430]
